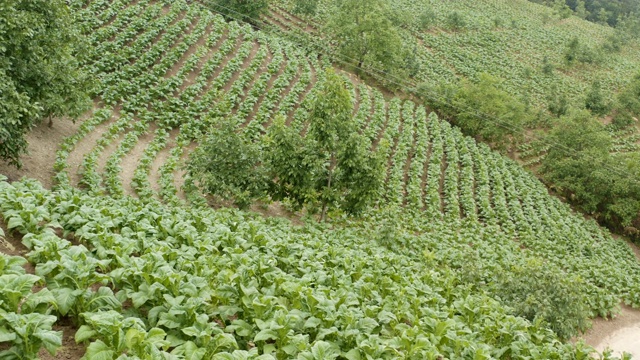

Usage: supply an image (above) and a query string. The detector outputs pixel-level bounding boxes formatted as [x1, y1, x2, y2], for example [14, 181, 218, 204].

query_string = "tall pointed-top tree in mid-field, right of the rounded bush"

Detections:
[266, 70, 384, 221]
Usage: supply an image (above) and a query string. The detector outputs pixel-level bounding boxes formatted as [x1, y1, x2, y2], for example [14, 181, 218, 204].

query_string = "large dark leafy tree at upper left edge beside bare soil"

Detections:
[0, 0, 89, 166]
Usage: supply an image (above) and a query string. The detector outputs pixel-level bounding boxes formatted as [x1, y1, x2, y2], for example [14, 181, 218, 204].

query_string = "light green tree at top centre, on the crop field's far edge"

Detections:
[327, 0, 403, 71]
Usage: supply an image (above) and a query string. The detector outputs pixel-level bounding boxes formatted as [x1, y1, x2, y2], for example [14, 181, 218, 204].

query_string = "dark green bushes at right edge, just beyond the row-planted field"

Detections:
[541, 112, 640, 227]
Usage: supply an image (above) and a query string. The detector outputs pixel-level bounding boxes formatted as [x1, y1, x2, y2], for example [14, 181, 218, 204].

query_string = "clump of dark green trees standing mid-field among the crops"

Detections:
[188, 69, 385, 220]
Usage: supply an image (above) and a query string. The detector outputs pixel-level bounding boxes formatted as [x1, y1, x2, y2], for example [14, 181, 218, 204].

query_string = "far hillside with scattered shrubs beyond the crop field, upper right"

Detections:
[268, 0, 640, 237]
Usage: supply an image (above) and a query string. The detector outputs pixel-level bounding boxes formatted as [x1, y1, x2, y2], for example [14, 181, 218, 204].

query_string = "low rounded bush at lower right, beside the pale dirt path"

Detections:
[494, 259, 590, 340]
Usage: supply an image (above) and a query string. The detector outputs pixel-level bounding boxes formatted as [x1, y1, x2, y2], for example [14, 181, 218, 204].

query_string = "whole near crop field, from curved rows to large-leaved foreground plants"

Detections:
[0, 0, 640, 359]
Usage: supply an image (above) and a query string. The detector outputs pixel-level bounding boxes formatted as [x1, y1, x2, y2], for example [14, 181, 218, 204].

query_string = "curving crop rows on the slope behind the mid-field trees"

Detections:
[55, 0, 640, 316]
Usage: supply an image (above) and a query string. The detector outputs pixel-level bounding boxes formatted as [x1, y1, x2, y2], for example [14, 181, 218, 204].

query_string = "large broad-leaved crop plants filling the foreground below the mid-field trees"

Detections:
[0, 174, 628, 360]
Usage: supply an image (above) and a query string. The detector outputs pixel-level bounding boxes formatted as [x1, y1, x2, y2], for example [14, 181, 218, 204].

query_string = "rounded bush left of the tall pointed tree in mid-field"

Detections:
[187, 121, 267, 208]
